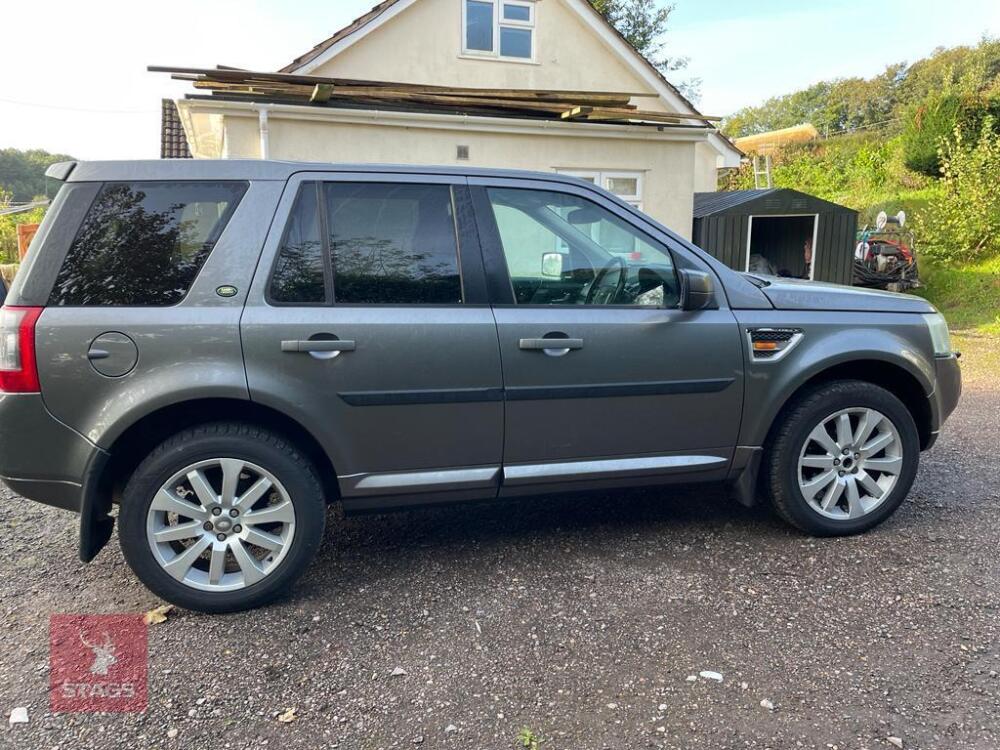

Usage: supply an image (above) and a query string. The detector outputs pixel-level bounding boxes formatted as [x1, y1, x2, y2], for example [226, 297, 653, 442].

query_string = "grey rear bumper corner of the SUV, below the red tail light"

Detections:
[0, 393, 102, 512]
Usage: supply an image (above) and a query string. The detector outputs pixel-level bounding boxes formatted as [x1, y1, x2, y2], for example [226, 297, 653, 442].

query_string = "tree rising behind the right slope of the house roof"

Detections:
[590, 0, 701, 100]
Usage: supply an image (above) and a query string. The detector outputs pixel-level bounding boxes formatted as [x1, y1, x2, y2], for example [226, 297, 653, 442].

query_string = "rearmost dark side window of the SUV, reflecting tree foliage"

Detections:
[49, 182, 246, 306]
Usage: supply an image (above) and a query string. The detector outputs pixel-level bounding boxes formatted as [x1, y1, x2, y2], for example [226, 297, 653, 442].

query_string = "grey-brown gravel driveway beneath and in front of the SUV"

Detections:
[0, 339, 1000, 750]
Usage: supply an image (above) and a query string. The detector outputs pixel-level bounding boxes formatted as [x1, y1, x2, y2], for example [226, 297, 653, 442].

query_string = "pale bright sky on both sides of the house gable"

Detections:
[0, 0, 1000, 159]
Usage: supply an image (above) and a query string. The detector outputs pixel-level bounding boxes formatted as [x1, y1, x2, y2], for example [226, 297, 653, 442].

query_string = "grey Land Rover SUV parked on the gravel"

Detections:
[0, 161, 961, 612]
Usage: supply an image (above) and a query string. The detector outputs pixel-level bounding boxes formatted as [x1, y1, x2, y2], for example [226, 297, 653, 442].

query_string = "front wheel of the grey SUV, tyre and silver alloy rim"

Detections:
[764, 380, 920, 536]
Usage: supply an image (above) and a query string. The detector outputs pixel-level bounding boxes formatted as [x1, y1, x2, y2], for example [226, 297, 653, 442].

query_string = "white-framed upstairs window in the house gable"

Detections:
[462, 0, 535, 61]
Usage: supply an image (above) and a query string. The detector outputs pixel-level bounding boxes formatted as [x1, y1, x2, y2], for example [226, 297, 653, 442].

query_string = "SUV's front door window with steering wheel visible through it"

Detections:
[488, 188, 679, 307]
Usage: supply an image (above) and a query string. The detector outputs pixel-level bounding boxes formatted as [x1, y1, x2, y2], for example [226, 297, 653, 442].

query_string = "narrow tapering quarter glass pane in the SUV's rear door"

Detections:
[271, 183, 327, 304]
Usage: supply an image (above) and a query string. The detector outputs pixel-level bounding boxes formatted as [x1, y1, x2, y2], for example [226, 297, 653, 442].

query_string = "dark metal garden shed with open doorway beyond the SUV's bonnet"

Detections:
[693, 188, 858, 284]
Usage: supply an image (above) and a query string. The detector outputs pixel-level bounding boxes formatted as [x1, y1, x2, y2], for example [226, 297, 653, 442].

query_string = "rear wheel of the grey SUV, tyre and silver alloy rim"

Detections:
[118, 422, 326, 612]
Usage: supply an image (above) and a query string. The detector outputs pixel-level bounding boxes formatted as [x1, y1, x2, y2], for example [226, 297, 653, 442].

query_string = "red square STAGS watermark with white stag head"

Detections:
[49, 615, 148, 713]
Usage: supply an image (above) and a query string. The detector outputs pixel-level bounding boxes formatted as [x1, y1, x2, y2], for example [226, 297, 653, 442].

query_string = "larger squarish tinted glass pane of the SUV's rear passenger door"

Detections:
[324, 182, 462, 305]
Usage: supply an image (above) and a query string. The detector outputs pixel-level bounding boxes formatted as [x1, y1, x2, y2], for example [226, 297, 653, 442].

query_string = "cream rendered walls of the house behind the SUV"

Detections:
[178, 0, 736, 237]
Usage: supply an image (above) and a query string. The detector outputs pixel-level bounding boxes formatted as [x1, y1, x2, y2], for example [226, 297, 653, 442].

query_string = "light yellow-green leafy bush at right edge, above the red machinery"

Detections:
[917, 116, 1000, 263]
